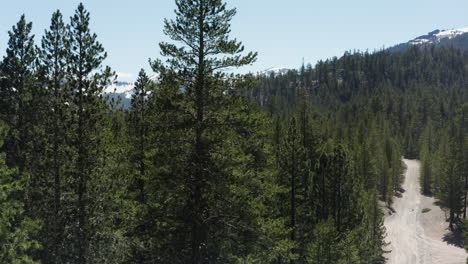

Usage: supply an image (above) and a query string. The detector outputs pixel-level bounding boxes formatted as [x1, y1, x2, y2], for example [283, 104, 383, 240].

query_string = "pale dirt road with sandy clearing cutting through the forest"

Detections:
[385, 159, 468, 264]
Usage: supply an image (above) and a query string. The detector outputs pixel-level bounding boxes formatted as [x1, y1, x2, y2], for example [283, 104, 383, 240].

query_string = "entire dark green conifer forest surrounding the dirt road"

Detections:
[0, 0, 468, 264]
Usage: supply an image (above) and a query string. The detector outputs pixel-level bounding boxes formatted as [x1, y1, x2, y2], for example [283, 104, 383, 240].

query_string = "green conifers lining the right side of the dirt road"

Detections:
[421, 104, 468, 227]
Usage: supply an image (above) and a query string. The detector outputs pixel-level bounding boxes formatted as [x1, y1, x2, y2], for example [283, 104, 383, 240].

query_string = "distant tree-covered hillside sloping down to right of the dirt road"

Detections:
[252, 46, 468, 224]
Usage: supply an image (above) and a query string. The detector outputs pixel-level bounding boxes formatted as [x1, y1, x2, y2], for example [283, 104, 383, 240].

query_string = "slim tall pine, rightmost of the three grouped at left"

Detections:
[68, 4, 113, 263]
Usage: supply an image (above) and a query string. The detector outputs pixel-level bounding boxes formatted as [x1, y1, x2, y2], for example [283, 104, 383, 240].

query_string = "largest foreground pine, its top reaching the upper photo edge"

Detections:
[148, 0, 288, 263]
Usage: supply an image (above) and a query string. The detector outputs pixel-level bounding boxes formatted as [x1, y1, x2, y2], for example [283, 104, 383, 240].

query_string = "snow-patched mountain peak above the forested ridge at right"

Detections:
[388, 28, 468, 52]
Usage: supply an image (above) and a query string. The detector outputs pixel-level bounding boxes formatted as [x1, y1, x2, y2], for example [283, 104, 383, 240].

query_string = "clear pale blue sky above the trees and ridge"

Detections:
[0, 0, 468, 81]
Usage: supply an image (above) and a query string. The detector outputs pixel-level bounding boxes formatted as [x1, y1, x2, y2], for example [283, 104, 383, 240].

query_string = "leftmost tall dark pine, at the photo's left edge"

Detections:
[0, 20, 46, 260]
